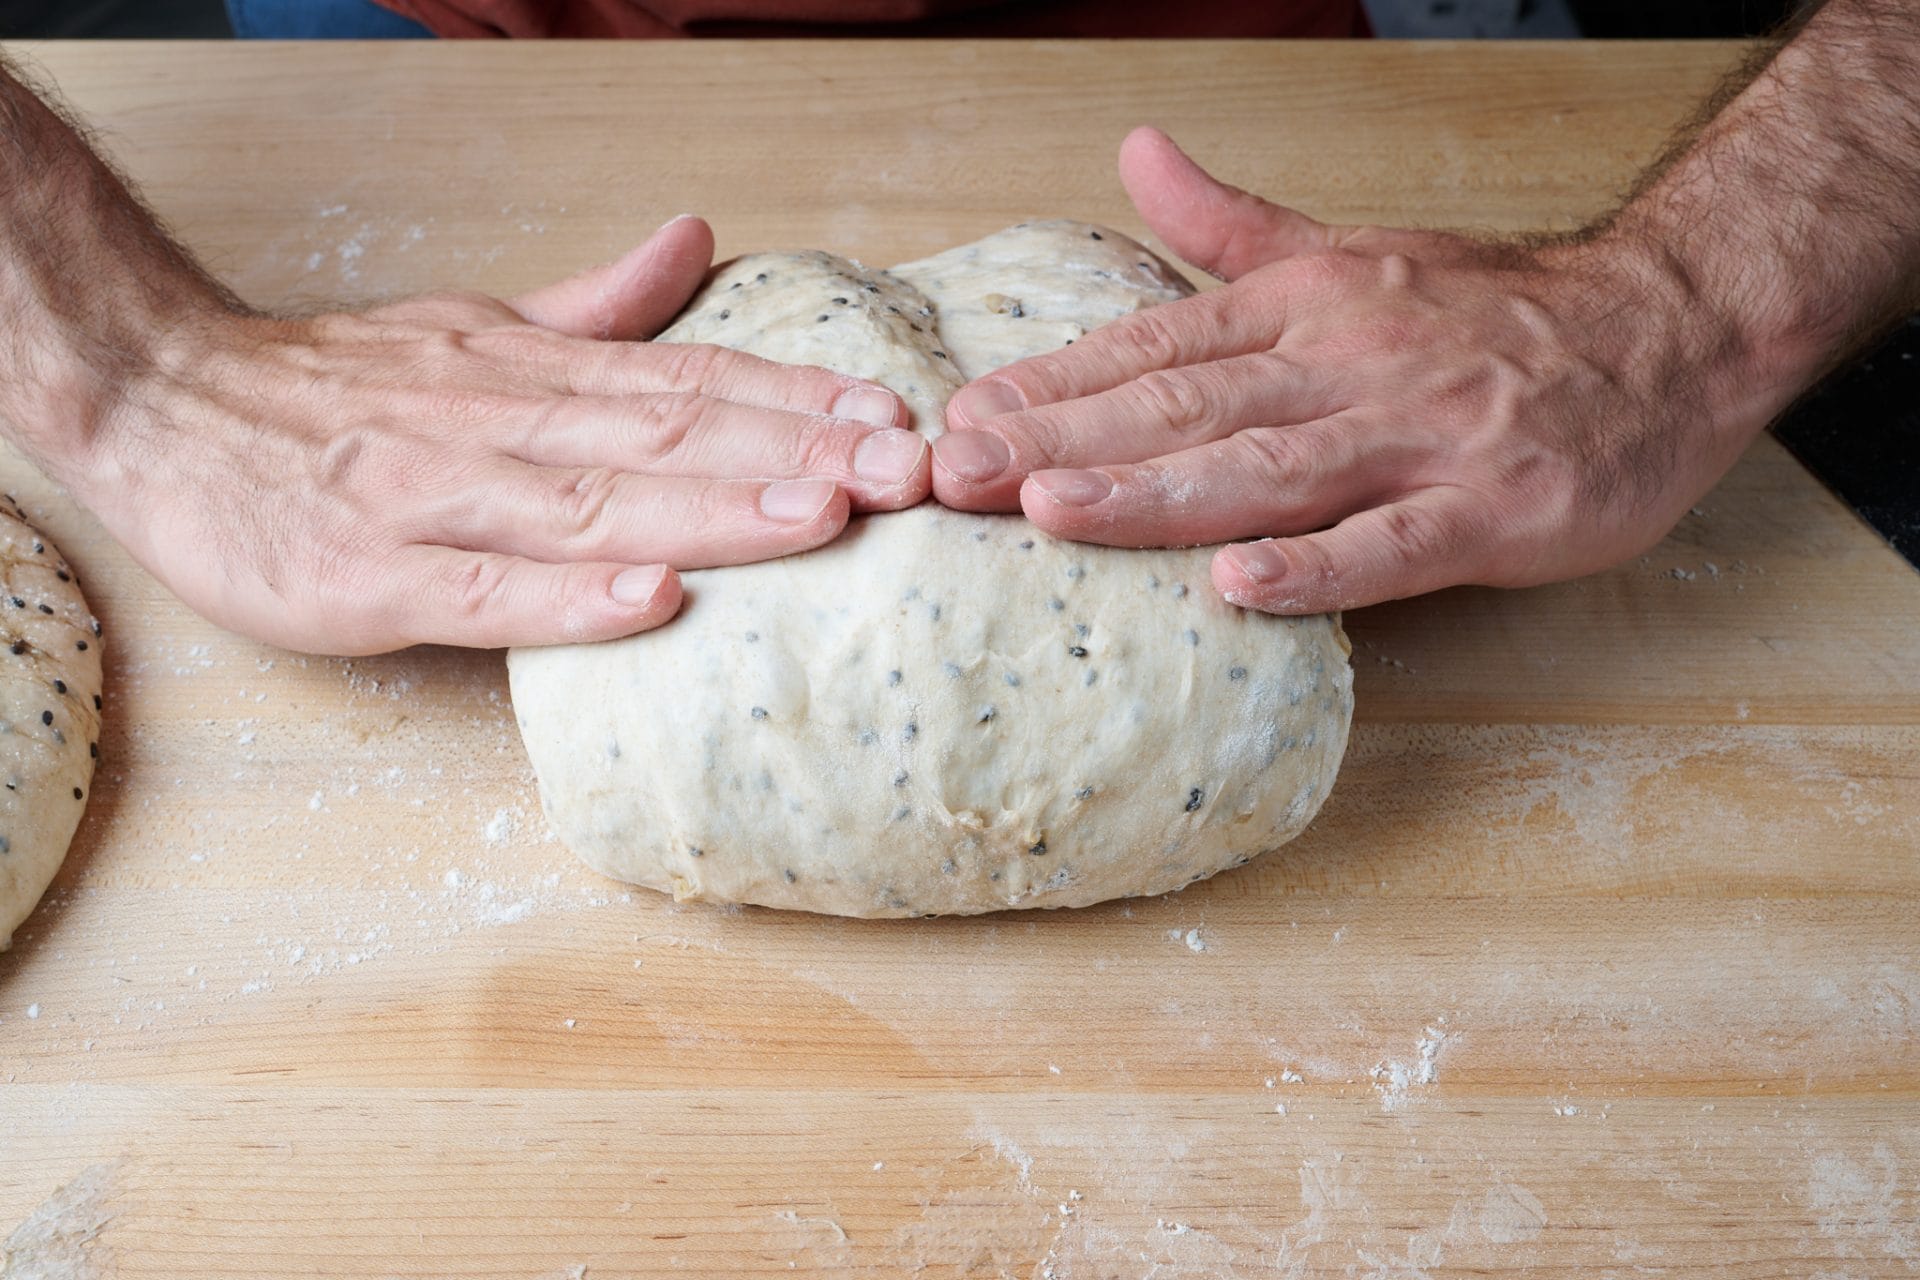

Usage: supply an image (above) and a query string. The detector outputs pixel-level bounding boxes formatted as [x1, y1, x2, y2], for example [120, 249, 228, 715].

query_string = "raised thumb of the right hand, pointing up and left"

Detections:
[1119, 125, 1340, 280]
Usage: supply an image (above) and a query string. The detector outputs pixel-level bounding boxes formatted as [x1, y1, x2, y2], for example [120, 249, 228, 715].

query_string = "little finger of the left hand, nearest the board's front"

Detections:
[388, 547, 680, 649]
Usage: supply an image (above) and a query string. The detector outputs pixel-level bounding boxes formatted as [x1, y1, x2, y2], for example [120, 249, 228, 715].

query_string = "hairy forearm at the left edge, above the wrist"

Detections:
[0, 52, 234, 480]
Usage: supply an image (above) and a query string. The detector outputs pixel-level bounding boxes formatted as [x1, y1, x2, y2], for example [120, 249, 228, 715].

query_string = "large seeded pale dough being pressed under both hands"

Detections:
[509, 223, 1352, 915]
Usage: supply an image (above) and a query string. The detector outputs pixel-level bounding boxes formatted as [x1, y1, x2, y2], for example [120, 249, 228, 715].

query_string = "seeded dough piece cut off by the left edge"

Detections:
[0, 497, 100, 950]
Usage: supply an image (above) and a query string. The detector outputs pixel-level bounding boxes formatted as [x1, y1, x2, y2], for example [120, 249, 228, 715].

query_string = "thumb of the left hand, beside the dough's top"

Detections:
[511, 213, 714, 342]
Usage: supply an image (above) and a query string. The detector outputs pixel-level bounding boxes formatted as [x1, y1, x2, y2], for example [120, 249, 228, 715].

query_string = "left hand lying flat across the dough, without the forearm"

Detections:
[56, 219, 929, 652]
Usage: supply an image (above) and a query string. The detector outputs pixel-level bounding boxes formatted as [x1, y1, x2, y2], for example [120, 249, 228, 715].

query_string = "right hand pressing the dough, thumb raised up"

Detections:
[933, 129, 1791, 614]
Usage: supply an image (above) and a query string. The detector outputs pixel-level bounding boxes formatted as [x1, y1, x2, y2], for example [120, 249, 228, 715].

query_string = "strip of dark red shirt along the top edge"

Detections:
[378, 0, 1367, 38]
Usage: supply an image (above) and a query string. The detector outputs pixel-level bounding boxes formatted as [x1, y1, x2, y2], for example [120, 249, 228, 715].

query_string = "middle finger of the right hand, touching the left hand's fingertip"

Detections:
[933, 351, 1342, 510]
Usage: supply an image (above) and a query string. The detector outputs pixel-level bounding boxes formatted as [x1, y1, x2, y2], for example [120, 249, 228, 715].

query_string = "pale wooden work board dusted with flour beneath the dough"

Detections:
[0, 42, 1920, 1280]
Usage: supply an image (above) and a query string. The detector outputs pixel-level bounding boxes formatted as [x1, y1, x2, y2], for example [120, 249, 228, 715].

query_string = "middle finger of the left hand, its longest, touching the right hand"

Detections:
[507, 393, 931, 510]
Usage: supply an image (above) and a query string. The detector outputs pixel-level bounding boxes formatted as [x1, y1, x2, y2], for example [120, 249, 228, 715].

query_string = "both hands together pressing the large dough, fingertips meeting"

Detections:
[90, 129, 1764, 652]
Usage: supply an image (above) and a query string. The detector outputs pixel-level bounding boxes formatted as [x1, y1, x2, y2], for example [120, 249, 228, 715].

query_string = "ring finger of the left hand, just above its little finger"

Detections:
[445, 462, 849, 570]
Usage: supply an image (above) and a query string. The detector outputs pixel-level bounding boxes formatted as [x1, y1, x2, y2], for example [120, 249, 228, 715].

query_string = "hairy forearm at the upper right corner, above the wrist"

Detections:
[1597, 0, 1920, 416]
